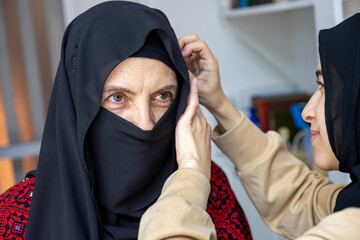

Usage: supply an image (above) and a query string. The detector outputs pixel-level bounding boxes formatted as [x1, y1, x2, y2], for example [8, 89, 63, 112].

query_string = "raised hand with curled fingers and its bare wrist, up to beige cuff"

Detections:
[178, 34, 241, 132]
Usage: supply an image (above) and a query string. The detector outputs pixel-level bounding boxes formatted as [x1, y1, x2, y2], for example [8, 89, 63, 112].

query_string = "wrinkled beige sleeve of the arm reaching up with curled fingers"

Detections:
[213, 112, 344, 239]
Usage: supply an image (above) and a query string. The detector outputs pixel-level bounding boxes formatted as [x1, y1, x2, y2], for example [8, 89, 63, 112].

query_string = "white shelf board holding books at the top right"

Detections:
[223, 0, 314, 18]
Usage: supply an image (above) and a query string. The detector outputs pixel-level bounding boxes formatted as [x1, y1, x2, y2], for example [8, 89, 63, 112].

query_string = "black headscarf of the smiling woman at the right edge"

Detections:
[319, 14, 360, 211]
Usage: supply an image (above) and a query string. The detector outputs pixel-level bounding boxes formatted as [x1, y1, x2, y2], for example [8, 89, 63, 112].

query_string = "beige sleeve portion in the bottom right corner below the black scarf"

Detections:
[297, 208, 360, 240]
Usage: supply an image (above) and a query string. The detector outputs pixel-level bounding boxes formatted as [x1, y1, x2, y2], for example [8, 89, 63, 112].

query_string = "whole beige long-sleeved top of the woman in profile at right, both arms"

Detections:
[139, 112, 360, 240]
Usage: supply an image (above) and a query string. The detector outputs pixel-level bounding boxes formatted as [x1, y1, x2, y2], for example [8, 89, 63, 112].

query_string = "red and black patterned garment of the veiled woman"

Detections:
[0, 163, 252, 240]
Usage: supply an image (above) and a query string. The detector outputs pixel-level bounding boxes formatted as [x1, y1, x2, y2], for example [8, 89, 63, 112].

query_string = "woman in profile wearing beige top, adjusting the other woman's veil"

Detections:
[140, 14, 360, 239]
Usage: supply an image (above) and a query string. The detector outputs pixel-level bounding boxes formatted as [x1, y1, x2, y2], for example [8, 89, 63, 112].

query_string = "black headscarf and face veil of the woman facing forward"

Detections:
[25, 1, 189, 240]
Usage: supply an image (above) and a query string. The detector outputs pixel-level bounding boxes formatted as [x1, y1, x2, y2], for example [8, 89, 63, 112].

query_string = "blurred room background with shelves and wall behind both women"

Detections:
[0, 0, 360, 240]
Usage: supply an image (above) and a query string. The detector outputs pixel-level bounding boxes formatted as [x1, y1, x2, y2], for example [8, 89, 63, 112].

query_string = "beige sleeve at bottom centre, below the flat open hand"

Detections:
[138, 169, 216, 240]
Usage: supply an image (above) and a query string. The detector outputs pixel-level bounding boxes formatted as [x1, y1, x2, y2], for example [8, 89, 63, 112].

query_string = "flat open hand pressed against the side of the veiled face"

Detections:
[175, 78, 211, 180]
